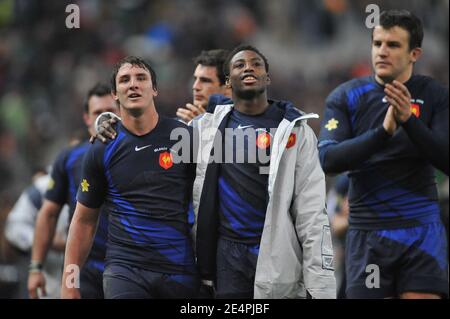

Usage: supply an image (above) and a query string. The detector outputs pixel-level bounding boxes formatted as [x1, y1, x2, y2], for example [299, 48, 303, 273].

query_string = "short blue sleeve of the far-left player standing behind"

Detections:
[45, 150, 69, 206]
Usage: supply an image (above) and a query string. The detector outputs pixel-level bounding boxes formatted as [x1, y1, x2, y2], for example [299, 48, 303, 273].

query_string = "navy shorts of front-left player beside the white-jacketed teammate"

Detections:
[103, 263, 200, 299]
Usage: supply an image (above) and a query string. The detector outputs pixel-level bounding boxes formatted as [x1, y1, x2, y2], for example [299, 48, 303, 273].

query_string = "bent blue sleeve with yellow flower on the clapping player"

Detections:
[319, 88, 390, 174]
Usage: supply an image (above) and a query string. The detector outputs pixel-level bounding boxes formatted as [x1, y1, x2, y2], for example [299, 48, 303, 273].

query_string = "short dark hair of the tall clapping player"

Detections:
[372, 10, 424, 50]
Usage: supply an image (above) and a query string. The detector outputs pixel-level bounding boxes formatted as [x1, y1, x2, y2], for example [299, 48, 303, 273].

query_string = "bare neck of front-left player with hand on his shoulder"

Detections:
[121, 105, 159, 136]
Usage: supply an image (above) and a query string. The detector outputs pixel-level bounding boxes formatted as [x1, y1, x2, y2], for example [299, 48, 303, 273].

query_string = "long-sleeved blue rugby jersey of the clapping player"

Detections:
[319, 75, 448, 229]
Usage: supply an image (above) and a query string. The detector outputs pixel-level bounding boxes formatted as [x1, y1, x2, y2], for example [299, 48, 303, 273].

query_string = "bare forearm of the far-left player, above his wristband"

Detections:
[31, 210, 58, 263]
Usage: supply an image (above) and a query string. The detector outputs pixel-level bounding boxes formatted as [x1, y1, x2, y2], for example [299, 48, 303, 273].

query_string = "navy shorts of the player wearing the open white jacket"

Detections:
[216, 238, 259, 299]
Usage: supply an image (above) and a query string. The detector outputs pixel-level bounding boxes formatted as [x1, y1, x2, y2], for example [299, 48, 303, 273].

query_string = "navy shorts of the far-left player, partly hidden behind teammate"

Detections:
[80, 260, 105, 299]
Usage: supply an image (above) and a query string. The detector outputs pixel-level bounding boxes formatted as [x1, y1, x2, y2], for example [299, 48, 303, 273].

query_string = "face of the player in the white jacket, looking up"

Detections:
[229, 50, 270, 98]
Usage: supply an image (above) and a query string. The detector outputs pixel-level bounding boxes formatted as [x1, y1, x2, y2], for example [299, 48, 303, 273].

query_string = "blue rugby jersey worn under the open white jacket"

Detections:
[218, 103, 284, 244]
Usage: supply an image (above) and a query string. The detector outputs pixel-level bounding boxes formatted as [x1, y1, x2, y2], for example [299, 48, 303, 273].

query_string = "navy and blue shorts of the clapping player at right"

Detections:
[345, 223, 448, 299]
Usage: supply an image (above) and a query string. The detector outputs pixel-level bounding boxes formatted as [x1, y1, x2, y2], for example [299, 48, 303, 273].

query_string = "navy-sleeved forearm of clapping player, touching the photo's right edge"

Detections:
[402, 112, 449, 176]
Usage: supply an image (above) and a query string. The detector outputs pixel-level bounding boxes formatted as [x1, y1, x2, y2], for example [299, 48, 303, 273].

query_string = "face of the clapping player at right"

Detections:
[372, 26, 421, 84]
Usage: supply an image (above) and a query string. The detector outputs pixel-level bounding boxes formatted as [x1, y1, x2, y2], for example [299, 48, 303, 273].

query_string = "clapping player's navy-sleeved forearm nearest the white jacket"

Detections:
[319, 127, 391, 174]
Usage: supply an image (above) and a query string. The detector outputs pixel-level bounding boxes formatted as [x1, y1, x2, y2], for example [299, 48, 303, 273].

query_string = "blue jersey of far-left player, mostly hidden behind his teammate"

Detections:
[45, 141, 108, 264]
